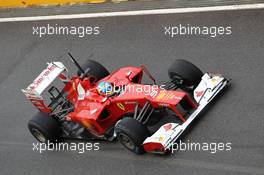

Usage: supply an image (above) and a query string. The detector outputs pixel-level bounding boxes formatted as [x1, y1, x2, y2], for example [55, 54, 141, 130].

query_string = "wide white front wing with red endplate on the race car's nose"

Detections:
[143, 73, 229, 153]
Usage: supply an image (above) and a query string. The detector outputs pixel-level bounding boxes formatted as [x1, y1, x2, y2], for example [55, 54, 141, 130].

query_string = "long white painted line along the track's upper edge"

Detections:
[0, 3, 264, 22]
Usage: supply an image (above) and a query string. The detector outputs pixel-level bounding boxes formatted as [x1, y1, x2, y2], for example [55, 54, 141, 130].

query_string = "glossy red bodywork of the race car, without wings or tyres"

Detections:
[54, 66, 196, 136]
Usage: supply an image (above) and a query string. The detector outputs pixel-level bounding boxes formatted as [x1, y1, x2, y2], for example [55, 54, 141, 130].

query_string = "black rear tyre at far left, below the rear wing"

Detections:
[28, 113, 61, 143]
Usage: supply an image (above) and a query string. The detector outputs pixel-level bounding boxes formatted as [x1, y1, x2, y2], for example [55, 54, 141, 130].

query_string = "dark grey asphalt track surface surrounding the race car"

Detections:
[0, 7, 264, 175]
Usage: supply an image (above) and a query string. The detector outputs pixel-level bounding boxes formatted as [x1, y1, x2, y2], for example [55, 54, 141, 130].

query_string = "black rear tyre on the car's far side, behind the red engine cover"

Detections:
[77, 60, 109, 81]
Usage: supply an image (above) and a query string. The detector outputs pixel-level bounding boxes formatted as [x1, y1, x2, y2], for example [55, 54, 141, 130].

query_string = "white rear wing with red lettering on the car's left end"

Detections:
[21, 62, 67, 113]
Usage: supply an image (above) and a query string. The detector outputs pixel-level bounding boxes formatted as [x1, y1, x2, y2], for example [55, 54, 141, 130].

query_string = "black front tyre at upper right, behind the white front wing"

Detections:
[168, 59, 203, 87]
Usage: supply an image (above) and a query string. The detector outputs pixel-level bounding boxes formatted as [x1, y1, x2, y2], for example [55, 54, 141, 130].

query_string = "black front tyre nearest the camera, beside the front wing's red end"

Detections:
[115, 117, 149, 154]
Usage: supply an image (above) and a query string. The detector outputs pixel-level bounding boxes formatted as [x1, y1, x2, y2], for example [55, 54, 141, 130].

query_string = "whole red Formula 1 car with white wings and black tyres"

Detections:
[22, 53, 228, 153]
